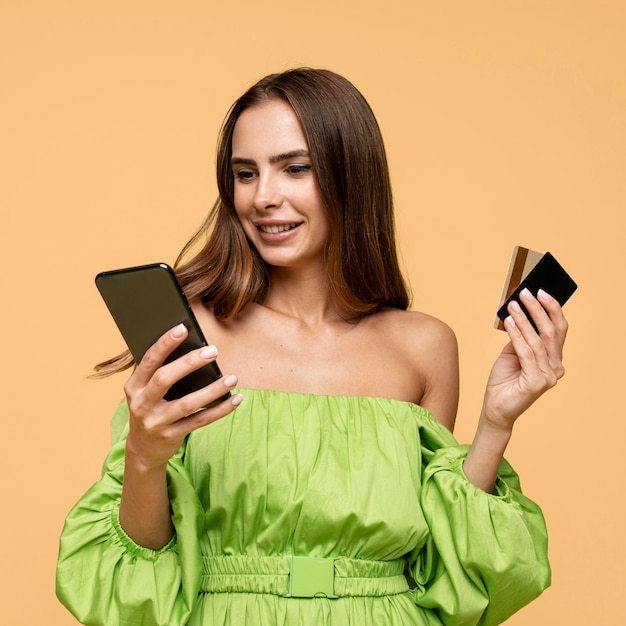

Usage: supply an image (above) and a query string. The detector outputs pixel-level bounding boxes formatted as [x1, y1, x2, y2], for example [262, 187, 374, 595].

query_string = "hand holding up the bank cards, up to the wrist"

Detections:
[481, 289, 567, 430]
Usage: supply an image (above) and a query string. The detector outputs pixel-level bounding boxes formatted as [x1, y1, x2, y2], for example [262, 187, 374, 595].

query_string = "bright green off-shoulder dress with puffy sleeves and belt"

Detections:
[57, 389, 550, 626]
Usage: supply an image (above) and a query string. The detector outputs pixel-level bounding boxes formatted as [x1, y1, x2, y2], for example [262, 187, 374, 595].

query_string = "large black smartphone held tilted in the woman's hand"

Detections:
[96, 263, 230, 402]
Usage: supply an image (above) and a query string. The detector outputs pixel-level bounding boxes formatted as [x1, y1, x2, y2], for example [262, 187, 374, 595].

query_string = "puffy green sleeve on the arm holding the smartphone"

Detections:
[56, 403, 204, 626]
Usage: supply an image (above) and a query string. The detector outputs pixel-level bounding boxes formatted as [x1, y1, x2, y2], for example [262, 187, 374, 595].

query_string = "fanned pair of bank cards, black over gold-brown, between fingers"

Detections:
[496, 246, 578, 332]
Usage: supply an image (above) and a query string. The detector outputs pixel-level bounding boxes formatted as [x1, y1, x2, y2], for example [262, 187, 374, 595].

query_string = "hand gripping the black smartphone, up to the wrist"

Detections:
[124, 324, 242, 470]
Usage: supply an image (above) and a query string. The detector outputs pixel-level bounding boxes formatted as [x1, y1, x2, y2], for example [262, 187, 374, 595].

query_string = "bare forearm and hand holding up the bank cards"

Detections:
[463, 290, 567, 492]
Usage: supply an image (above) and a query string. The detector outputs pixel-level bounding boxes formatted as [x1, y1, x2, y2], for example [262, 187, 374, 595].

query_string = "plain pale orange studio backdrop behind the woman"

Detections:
[0, 0, 626, 626]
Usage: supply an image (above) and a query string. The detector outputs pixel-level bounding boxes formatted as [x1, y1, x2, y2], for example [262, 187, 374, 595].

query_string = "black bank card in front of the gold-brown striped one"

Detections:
[498, 252, 578, 330]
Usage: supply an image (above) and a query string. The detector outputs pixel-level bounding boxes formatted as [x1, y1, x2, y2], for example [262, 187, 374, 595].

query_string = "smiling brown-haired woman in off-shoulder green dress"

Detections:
[57, 69, 567, 626]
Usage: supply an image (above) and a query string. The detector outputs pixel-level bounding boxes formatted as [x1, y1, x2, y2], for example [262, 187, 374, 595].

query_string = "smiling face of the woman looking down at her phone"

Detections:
[231, 100, 328, 269]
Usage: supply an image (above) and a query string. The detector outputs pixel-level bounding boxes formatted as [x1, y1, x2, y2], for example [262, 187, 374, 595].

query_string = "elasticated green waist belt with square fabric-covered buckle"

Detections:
[200, 555, 409, 598]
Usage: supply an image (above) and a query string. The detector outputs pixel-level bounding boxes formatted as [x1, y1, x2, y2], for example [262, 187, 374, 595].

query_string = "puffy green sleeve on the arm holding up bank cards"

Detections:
[411, 416, 550, 626]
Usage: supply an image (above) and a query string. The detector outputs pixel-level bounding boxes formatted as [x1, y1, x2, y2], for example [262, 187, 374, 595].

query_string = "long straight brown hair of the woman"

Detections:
[97, 68, 410, 375]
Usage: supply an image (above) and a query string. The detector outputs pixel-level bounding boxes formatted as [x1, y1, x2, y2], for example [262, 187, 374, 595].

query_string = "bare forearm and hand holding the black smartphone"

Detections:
[119, 324, 242, 549]
